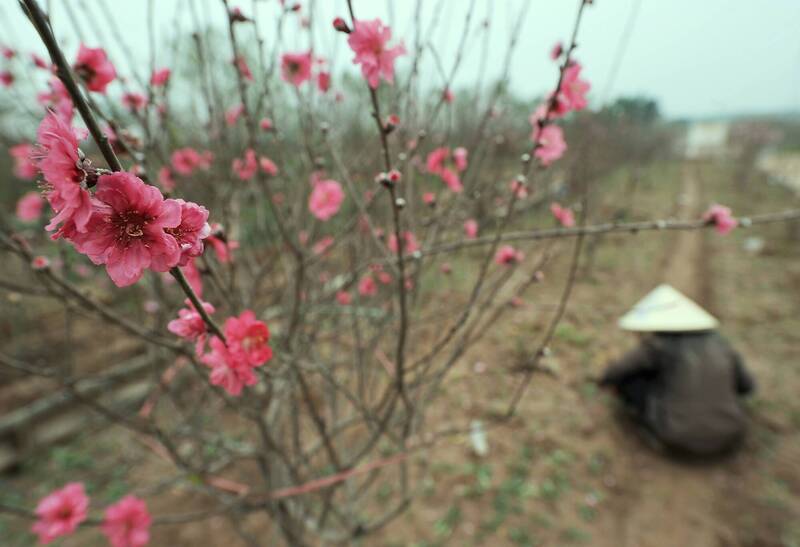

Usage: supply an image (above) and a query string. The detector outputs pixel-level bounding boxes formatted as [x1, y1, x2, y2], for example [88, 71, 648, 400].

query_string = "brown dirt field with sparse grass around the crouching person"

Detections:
[0, 156, 800, 547]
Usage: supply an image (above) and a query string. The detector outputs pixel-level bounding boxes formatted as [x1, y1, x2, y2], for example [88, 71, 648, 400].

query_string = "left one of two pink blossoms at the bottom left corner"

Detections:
[31, 482, 89, 544]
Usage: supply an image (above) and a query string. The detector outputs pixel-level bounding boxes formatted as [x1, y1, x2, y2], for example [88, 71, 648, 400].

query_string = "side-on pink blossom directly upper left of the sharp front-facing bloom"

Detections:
[36, 112, 92, 236]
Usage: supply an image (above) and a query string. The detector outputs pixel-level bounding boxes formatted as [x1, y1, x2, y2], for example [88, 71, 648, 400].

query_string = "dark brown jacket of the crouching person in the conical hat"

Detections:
[601, 332, 755, 454]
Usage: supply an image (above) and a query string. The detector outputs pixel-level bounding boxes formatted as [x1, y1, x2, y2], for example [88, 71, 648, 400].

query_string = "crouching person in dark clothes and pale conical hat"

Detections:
[600, 285, 755, 456]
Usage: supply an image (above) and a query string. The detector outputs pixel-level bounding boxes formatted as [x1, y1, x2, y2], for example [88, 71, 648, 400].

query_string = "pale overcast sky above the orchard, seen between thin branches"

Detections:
[0, 0, 800, 117]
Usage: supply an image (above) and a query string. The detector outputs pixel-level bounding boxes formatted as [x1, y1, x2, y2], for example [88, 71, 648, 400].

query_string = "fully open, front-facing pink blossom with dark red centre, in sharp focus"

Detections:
[73, 172, 181, 287]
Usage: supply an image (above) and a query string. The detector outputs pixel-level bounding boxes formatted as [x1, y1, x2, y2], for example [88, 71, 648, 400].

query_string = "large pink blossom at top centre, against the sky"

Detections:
[347, 19, 406, 89]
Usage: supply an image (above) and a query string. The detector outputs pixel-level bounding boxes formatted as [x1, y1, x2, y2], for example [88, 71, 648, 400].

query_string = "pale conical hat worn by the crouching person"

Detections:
[619, 285, 719, 332]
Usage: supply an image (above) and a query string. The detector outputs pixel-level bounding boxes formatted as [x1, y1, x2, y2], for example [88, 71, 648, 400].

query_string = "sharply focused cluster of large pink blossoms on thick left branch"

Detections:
[37, 113, 210, 287]
